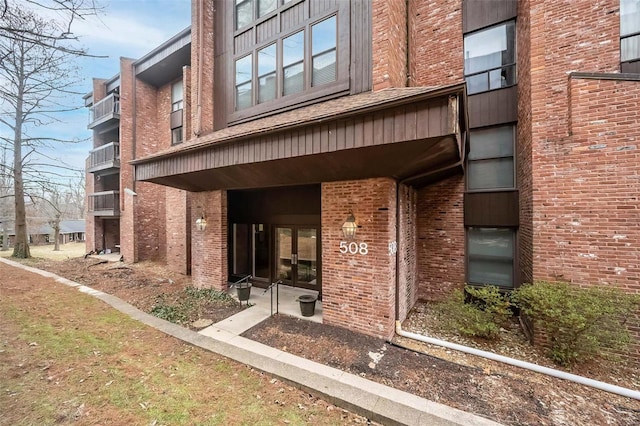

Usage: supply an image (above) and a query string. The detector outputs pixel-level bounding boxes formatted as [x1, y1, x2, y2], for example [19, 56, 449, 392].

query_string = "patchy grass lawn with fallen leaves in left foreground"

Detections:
[0, 263, 366, 426]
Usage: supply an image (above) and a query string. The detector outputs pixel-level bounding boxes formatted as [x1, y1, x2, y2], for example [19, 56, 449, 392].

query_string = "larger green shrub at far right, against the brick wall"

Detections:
[513, 282, 640, 366]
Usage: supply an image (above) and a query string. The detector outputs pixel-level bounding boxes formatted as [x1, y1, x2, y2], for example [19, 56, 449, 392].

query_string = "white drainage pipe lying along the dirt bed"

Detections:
[396, 321, 640, 400]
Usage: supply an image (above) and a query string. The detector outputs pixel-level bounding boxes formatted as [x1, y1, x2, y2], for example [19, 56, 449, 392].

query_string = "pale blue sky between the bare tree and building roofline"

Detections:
[3, 0, 191, 185]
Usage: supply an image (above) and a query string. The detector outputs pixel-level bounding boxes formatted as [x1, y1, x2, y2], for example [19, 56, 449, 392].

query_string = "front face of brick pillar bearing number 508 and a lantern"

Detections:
[322, 178, 396, 338]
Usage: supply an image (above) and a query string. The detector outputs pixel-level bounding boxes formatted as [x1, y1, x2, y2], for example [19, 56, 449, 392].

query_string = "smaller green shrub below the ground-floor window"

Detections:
[438, 286, 511, 339]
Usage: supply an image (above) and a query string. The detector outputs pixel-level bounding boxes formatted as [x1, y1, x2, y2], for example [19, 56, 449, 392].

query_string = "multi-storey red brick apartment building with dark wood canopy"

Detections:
[87, 0, 640, 350]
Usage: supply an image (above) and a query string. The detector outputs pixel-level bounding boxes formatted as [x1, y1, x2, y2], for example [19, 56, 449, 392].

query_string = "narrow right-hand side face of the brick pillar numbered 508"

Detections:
[398, 185, 418, 321]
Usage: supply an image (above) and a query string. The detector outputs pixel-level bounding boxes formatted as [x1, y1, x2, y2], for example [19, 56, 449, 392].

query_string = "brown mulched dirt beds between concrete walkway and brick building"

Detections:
[21, 259, 640, 425]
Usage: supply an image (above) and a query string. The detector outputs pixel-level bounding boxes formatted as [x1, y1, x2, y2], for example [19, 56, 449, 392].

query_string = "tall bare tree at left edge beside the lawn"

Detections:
[0, 5, 94, 258]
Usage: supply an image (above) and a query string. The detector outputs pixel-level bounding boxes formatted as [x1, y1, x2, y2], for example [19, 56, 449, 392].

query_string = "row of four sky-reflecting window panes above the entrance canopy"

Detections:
[235, 15, 338, 111]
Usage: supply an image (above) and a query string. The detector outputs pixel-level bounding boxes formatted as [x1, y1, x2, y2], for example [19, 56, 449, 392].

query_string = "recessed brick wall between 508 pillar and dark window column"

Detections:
[417, 176, 465, 300]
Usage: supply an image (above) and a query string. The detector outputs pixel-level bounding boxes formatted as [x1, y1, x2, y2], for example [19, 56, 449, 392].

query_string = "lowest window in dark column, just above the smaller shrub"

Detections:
[467, 227, 516, 288]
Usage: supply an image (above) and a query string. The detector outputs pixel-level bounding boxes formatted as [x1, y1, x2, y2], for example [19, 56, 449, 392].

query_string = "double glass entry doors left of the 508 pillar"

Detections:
[274, 226, 320, 291]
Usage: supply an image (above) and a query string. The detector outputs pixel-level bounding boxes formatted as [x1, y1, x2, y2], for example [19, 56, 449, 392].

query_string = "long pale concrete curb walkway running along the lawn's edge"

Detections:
[0, 258, 498, 426]
